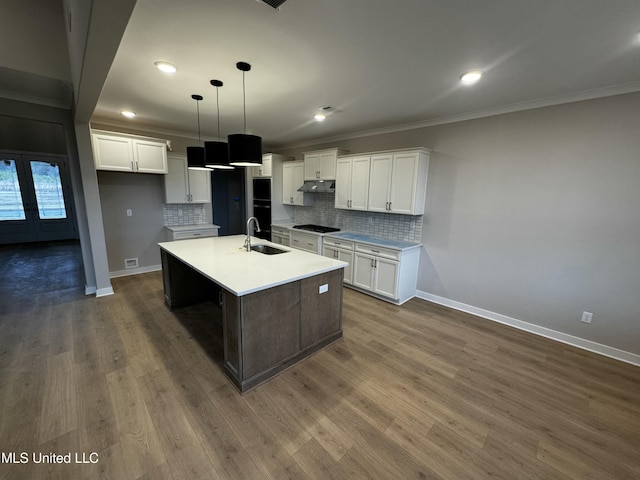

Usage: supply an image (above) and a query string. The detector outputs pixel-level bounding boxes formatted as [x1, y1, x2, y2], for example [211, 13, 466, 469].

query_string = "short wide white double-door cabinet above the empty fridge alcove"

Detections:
[91, 131, 168, 174]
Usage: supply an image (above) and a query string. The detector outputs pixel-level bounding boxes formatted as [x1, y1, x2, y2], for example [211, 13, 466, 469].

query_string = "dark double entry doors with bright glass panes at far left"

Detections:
[0, 153, 76, 243]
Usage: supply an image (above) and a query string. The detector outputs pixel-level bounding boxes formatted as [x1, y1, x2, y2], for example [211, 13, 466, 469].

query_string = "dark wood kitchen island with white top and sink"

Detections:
[159, 235, 347, 393]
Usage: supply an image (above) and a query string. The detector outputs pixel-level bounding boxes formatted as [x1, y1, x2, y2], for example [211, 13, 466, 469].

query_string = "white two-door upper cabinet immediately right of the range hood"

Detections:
[335, 156, 370, 210]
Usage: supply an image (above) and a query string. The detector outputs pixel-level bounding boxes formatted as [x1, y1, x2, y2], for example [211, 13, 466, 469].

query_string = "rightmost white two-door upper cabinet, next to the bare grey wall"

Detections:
[367, 149, 429, 215]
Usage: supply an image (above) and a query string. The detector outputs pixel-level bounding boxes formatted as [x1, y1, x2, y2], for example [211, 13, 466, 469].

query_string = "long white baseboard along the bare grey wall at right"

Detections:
[416, 290, 640, 366]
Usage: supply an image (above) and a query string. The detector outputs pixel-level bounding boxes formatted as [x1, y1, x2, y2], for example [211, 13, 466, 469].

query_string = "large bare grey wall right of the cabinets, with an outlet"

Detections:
[282, 93, 640, 354]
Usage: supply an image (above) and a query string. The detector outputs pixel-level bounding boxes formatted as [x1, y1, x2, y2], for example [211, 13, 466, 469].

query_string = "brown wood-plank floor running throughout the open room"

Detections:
[0, 244, 640, 480]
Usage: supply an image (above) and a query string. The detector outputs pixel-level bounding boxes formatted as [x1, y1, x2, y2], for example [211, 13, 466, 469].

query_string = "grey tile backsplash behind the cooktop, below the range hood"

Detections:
[290, 193, 422, 242]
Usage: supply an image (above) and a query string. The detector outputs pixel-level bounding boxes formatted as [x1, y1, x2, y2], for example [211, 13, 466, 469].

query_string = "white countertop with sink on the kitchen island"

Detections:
[158, 235, 348, 296]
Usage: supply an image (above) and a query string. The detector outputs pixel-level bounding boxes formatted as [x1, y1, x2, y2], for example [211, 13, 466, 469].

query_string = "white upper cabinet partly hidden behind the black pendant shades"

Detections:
[164, 155, 211, 203]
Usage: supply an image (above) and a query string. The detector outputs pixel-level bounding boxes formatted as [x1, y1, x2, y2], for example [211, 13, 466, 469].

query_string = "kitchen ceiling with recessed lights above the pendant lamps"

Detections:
[93, 0, 640, 147]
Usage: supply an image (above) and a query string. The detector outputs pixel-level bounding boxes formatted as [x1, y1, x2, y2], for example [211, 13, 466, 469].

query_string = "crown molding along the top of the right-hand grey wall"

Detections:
[276, 82, 640, 149]
